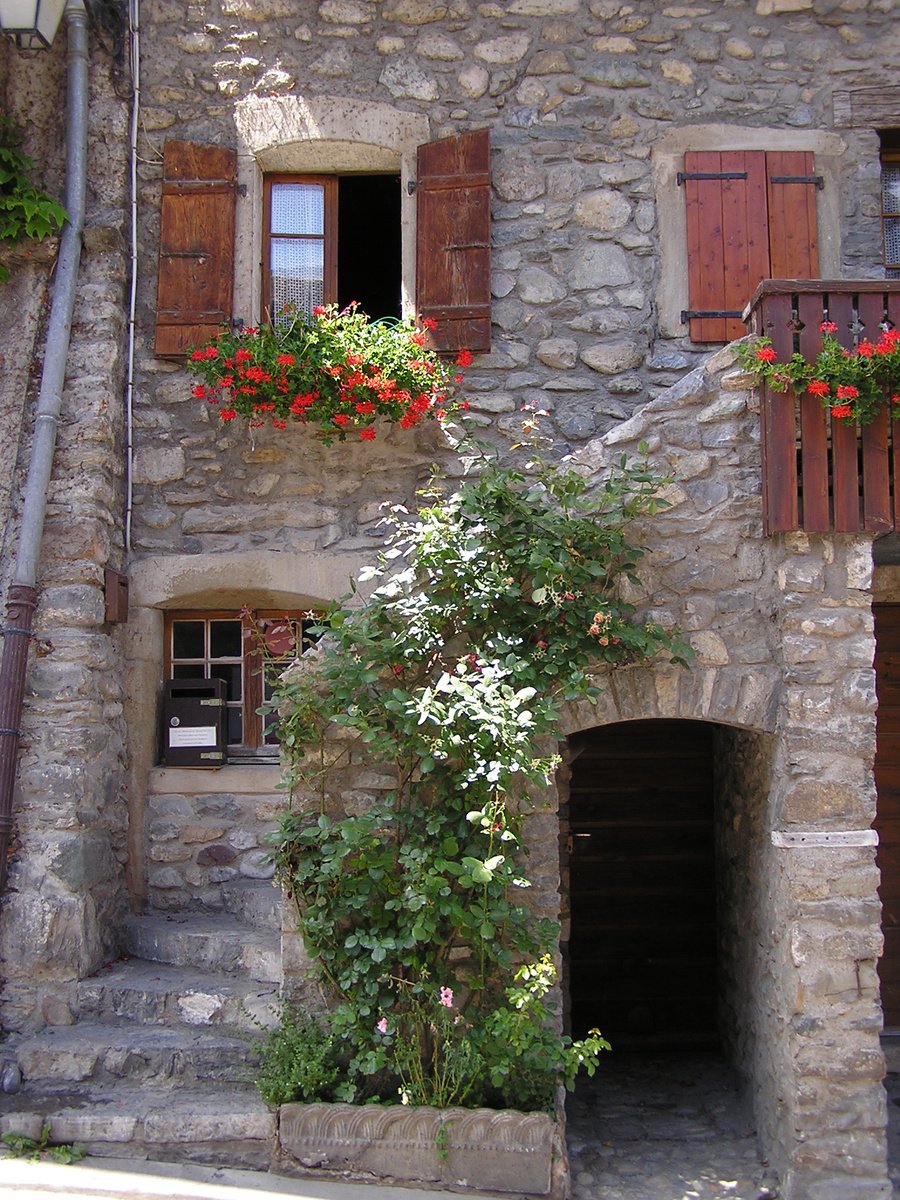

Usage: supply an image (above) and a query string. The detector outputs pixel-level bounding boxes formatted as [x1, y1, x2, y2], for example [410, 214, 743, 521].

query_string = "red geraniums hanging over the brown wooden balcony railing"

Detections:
[738, 320, 900, 425]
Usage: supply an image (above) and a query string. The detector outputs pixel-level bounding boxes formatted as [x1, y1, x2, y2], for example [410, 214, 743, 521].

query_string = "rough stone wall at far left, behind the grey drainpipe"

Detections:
[0, 36, 128, 1030]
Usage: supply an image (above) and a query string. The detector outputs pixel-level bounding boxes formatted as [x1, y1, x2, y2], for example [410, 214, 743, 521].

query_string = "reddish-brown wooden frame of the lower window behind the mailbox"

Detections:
[163, 607, 319, 762]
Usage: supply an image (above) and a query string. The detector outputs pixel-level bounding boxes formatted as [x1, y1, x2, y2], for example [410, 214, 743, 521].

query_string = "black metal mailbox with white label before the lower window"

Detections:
[162, 679, 227, 767]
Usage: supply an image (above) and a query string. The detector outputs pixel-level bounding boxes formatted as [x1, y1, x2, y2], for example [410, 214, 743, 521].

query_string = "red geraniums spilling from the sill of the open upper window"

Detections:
[187, 304, 472, 445]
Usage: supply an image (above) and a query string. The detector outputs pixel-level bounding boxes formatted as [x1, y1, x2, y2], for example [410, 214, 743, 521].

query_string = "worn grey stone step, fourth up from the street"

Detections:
[125, 912, 281, 983]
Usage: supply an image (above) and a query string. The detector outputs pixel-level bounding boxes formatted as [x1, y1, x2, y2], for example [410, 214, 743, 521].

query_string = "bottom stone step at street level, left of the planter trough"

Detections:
[0, 1082, 276, 1170]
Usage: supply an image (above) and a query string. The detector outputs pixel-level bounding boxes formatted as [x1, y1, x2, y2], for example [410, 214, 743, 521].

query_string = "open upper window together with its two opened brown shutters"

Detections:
[156, 130, 491, 359]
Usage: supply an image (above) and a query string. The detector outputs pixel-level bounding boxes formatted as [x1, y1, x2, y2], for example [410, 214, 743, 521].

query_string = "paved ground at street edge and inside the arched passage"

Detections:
[0, 1054, 900, 1200]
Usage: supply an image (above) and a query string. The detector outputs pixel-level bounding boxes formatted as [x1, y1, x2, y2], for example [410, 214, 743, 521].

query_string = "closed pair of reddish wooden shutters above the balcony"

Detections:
[678, 150, 818, 342]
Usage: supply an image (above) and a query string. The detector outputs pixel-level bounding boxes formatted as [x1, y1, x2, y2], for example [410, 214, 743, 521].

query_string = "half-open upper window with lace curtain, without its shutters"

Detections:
[263, 175, 401, 320]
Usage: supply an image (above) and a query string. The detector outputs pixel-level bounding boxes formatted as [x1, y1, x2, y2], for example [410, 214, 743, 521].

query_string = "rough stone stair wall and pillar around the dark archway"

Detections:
[571, 350, 889, 1200]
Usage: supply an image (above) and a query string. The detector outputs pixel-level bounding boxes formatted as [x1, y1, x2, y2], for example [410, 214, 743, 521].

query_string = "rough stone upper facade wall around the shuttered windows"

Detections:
[128, 0, 893, 553]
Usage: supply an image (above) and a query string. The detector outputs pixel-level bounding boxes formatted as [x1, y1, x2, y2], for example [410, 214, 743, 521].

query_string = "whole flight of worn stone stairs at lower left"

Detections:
[0, 880, 281, 1170]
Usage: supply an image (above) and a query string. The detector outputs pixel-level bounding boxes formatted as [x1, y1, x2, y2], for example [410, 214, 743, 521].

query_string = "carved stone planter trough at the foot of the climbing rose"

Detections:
[278, 1104, 566, 1196]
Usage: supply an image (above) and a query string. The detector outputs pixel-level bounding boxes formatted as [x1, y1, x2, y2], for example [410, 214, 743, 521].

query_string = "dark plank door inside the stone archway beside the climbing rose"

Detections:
[563, 720, 719, 1049]
